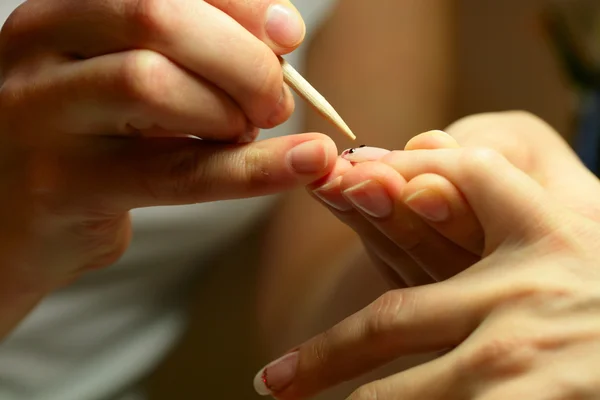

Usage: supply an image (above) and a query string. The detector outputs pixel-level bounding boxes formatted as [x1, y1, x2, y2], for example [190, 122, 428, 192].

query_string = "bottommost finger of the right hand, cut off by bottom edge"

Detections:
[348, 324, 600, 400]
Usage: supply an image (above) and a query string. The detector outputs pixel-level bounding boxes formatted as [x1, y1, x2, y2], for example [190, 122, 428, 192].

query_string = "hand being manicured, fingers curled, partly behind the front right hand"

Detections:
[309, 112, 600, 287]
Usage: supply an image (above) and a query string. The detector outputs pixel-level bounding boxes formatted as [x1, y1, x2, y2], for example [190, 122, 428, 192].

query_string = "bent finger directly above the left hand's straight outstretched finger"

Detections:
[5, 50, 248, 141]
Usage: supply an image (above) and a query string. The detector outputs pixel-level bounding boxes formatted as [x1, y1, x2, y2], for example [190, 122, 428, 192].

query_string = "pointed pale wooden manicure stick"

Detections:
[279, 57, 356, 140]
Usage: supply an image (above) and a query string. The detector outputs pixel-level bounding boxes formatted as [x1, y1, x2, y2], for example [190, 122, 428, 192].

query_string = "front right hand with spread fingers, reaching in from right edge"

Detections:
[255, 135, 600, 400]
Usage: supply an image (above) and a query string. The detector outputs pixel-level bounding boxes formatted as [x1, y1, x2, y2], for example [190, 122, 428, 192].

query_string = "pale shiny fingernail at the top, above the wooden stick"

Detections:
[265, 4, 306, 47]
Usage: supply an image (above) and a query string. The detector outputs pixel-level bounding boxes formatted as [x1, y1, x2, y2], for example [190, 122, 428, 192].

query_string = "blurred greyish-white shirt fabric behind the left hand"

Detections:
[0, 0, 333, 400]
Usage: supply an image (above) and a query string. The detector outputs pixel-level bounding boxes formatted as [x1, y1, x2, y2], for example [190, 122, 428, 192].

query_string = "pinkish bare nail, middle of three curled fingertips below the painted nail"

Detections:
[344, 180, 394, 218]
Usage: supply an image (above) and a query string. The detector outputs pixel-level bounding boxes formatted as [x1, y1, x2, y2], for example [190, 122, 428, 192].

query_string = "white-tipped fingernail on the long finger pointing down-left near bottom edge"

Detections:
[254, 352, 298, 396]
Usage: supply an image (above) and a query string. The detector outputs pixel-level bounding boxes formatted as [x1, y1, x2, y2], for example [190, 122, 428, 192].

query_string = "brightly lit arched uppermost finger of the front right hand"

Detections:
[381, 148, 562, 251]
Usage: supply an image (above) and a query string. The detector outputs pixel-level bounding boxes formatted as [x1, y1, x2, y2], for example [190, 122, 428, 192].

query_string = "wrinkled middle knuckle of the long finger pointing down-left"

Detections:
[365, 289, 414, 337]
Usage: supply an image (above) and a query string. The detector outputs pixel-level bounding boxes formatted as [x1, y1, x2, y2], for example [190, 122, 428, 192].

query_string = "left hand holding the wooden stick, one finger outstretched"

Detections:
[0, 0, 337, 312]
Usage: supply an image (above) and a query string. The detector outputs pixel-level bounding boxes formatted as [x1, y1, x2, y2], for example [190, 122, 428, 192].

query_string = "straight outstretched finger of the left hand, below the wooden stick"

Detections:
[55, 134, 337, 210]
